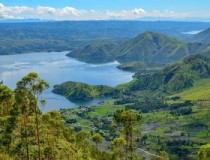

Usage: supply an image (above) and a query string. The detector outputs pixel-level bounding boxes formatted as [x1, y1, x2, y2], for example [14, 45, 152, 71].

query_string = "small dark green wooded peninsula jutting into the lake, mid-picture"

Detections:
[52, 81, 114, 100]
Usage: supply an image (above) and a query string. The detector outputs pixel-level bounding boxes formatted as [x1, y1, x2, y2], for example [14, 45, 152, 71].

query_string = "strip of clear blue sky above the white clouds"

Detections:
[0, 0, 210, 11]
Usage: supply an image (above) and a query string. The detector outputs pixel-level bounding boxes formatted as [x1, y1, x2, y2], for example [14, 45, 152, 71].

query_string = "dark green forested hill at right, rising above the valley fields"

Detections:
[131, 55, 210, 94]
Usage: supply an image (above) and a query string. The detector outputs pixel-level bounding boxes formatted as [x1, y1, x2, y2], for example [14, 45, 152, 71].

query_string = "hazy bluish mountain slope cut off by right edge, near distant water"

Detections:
[189, 28, 210, 43]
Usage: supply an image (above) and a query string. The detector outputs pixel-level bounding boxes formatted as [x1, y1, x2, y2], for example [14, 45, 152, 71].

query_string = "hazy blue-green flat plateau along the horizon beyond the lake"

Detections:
[0, 21, 209, 55]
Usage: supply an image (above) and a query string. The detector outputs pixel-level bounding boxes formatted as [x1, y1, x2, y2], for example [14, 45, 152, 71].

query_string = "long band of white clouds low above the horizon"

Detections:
[0, 3, 210, 20]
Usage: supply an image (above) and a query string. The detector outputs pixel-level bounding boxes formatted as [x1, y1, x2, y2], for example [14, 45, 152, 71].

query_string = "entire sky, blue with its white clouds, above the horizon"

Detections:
[0, 0, 210, 21]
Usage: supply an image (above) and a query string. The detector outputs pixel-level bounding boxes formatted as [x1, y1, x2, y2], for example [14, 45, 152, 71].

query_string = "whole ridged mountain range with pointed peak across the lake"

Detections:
[67, 32, 208, 63]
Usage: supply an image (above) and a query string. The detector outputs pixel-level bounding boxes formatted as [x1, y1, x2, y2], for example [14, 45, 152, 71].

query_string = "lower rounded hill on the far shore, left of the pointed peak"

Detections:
[67, 43, 116, 63]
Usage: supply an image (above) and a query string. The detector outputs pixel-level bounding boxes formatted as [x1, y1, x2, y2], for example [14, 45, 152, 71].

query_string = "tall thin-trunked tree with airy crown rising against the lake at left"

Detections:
[16, 72, 49, 160]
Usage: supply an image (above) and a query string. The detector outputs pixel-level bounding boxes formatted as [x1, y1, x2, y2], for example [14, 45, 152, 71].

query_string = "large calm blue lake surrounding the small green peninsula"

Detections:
[0, 52, 133, 112]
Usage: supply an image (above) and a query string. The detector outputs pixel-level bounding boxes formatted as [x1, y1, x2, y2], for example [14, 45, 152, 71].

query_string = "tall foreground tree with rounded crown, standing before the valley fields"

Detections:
[114, 110, 141, 160]
